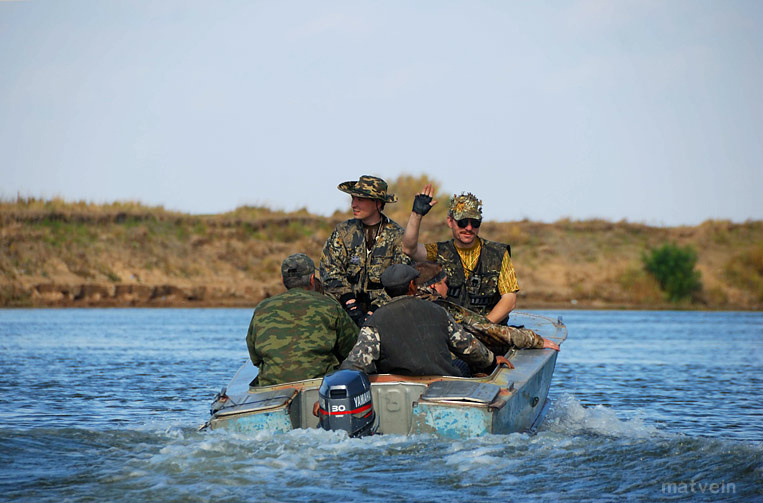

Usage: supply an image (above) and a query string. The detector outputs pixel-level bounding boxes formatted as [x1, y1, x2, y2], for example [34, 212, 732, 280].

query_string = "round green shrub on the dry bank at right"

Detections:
[642, 243, 702, 302]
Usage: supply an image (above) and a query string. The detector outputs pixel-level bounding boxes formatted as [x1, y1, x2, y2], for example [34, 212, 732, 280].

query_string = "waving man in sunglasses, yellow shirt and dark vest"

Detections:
[403, 184, 519, 324]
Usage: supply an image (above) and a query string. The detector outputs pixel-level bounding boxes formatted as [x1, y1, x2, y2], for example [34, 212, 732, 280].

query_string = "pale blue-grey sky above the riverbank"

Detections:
[0, 0, 763, 226]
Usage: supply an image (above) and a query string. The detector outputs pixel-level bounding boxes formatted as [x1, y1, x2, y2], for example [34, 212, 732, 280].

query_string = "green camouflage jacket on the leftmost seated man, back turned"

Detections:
[246, 288, 358, 386]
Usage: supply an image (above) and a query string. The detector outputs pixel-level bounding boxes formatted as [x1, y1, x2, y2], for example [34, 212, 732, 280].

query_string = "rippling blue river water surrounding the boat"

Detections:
[0, 309, 763, 503]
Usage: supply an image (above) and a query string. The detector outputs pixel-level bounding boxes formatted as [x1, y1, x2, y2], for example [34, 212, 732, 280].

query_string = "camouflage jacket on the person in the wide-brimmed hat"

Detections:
[320, 215, 411, 307]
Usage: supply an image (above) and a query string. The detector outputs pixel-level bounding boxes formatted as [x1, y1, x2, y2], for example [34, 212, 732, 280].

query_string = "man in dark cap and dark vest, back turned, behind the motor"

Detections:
[340, 264, 506, 376]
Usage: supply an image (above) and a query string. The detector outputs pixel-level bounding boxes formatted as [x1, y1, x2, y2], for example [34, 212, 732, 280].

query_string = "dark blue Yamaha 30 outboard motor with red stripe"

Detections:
[318, 370, 379, 437]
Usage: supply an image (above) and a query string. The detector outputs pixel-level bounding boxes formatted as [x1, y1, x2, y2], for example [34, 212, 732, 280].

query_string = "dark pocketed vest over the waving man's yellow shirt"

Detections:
[437, 238, 511, 315]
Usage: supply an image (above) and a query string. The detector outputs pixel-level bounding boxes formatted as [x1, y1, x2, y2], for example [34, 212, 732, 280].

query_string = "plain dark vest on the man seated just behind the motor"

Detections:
[366, 296, 461, 376]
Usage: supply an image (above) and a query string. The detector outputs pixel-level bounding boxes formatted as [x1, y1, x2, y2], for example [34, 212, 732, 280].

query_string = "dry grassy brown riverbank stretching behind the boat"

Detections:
[0, 176, 763, 310]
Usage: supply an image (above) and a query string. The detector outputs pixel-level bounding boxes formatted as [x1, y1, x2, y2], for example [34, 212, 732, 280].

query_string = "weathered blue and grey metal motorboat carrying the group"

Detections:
[202, 313, 567, 438]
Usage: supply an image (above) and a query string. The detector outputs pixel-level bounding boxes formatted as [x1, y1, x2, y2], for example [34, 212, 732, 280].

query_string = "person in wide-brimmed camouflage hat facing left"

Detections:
[320, 175, 410, 325]
